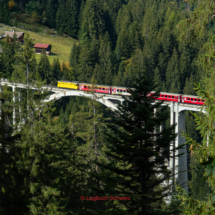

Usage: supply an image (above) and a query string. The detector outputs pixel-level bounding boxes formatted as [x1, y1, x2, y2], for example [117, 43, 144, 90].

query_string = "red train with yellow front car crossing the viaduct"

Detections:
[58, 80, 204, 105]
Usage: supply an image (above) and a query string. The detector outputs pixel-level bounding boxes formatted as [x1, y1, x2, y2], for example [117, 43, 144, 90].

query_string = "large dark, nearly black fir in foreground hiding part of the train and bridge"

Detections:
[95, 74, 176, 214]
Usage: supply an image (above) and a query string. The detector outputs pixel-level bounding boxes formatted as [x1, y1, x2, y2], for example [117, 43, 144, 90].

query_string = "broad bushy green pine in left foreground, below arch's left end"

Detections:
[18, 100, 85, 214]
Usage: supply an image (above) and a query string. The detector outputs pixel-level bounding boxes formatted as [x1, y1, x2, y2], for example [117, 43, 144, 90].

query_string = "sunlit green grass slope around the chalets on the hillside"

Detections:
[0, 23, 78, 63]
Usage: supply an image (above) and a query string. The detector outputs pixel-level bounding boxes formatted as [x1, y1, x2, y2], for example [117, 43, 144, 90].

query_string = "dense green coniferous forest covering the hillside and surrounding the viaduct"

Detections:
[0, 0, 215, 215]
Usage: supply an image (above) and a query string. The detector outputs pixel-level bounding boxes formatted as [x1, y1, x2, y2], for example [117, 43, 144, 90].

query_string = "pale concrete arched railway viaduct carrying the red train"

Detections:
[0, 80, 204, 193]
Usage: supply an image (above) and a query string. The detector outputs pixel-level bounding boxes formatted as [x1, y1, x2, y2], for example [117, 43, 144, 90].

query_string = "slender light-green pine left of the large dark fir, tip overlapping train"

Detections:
[69, 78, 106, 210]
